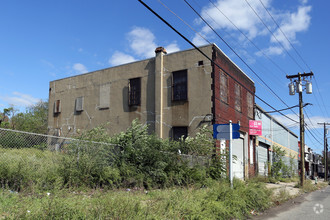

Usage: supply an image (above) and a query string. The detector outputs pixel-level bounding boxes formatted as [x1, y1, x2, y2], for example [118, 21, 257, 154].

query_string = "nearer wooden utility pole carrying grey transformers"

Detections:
[286, 72, 314, 186]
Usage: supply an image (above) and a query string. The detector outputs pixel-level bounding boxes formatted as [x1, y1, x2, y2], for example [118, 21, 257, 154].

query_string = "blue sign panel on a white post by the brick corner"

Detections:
[213, 124, 240, 140]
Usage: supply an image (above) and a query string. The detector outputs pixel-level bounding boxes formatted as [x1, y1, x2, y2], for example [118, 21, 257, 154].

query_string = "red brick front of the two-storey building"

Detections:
[212, 46, 256, 177]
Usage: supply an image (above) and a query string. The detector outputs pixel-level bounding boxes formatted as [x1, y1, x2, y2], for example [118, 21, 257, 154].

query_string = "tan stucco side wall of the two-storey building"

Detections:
[48, 45, 212, 138]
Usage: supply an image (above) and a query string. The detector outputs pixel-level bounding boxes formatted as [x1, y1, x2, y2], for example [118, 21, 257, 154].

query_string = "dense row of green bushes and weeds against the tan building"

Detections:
[0, 120, 226, 190]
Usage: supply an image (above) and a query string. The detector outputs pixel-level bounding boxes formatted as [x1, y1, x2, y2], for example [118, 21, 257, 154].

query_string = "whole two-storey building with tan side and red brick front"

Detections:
[48, 44, 255, 178]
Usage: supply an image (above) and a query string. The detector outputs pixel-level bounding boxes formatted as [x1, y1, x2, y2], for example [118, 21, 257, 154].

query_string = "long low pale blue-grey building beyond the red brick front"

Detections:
[255, 105, 299, 176]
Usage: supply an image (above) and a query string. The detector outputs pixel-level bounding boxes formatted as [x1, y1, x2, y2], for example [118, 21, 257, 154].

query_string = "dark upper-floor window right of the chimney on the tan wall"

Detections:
[172, 70, 188, 101]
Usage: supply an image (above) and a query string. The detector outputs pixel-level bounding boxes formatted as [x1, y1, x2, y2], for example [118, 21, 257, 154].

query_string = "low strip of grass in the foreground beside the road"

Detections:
[0, 180, 271, 219]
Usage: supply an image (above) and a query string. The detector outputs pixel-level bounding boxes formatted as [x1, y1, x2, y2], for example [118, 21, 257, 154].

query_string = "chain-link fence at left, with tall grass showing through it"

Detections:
[0, 128, 118, 191]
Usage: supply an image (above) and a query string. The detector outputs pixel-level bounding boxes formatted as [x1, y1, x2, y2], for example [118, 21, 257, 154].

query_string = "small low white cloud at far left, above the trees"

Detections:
[0, 92, 40, 107]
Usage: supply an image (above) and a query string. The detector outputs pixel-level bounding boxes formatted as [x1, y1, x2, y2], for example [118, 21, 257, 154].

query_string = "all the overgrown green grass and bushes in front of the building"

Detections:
[0, 121, 270, 219]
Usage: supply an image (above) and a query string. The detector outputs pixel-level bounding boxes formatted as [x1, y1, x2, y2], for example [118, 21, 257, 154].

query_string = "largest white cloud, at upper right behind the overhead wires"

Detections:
[199, 0, 311, 56]
